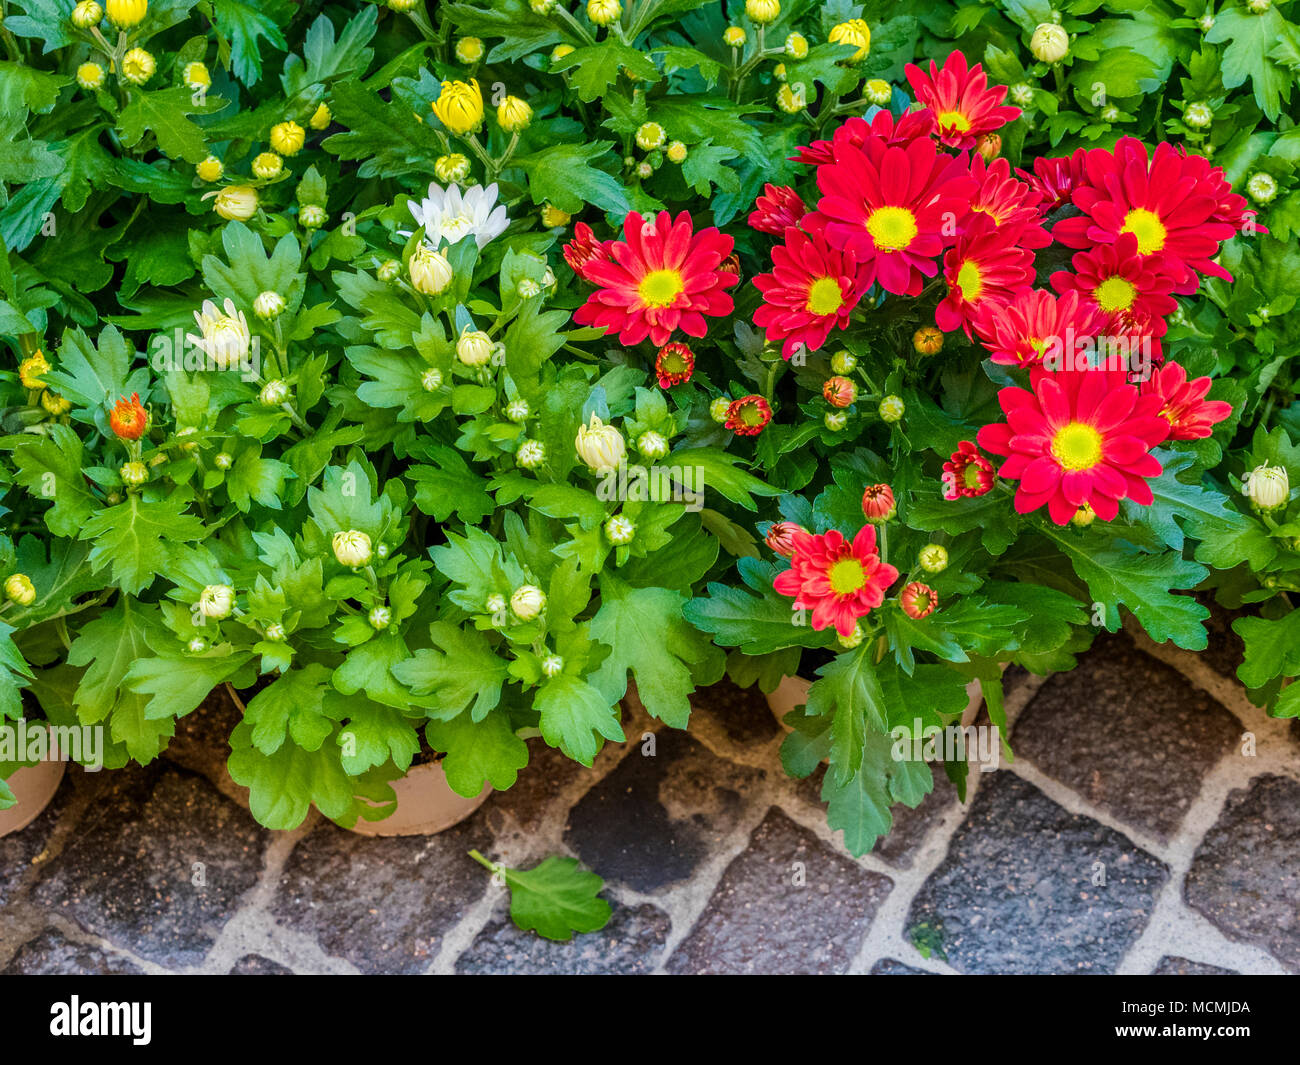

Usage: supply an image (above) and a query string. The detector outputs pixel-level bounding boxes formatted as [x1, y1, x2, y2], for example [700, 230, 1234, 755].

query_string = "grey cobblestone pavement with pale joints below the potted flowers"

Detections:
[0, 621, 1300, 975]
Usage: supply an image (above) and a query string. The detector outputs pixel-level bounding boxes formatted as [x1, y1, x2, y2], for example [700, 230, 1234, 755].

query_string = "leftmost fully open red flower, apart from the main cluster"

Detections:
[573, 211, 738, 345]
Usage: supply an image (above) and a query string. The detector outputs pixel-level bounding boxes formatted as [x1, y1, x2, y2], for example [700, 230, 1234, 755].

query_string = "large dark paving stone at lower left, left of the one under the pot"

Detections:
[33, 762, 270, 967]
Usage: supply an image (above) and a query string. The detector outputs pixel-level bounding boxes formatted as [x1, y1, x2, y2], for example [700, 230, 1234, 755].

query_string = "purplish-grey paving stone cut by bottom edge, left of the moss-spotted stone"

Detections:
[667, 809, 893, 974]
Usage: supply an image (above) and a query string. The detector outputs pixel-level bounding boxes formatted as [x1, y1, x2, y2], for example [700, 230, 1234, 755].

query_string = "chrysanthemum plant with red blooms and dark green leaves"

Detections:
[639, 53, 1268, 852]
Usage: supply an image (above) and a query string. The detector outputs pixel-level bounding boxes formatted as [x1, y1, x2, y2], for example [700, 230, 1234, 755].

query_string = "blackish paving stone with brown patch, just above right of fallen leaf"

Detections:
[564, 730, 766, 893]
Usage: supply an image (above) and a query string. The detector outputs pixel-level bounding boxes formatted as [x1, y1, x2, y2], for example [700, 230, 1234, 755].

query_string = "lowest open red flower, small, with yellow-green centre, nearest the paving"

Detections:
[772, 525, 898, 637]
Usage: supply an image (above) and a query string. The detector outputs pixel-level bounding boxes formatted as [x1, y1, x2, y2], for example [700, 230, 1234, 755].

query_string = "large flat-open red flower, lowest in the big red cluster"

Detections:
[976, 367, 1169, 525]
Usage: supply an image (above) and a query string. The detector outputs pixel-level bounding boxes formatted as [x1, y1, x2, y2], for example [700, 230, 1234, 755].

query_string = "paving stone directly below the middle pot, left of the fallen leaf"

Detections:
[272, 816, 493, 973]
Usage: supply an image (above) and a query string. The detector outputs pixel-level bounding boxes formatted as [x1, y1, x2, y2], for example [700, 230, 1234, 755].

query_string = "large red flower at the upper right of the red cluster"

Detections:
[1052, 137, 1245, 294]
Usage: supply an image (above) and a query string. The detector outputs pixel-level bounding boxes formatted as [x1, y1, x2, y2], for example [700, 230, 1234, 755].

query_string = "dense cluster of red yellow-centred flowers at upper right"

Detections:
[749, 52, 1249, 524]
